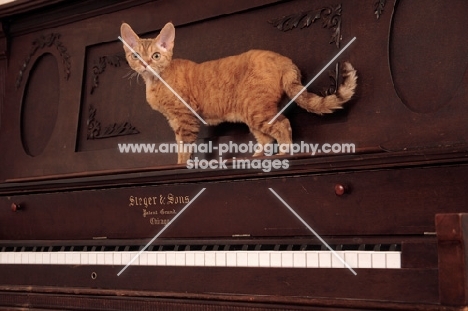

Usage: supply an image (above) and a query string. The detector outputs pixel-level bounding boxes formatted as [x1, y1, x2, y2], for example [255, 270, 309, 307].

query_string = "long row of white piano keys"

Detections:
[0, 250, 401, 269]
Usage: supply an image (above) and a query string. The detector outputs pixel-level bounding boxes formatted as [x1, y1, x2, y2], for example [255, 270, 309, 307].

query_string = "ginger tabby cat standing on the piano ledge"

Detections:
[120, 23, 357, 164]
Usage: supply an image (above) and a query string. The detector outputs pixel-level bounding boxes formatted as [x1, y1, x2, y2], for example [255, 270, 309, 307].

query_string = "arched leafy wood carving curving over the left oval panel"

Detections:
[16, 33, 71, 89]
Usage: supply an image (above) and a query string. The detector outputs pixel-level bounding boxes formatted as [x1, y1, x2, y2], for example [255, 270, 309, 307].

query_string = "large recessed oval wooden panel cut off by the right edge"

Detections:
[390, 0, 468, 113]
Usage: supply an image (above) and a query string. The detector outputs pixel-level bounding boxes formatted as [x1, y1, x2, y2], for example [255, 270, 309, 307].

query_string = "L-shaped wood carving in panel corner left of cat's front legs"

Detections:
[86, 105, 140, 140]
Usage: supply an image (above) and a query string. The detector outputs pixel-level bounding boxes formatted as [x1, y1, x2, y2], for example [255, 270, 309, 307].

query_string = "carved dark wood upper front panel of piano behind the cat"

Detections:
[0, 0, 468, 180]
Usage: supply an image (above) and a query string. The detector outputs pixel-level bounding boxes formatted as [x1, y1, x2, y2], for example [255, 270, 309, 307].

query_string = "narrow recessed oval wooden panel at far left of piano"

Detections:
[21, 53, 60, 157]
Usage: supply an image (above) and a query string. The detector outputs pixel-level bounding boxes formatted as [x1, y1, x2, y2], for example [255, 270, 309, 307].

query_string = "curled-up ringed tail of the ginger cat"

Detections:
[282, 62, 357, 115]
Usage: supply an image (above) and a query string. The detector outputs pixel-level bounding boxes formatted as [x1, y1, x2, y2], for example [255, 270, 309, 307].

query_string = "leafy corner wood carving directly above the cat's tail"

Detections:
[268, 4, 341, 48]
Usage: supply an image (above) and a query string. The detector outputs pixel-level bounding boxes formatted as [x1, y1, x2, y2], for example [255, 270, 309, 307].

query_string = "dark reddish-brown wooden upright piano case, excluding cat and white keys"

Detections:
[0, 0, 468, 310]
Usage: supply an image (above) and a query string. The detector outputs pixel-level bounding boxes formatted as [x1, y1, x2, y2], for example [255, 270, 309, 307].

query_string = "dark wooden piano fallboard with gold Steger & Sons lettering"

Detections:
[0, 165, 468, 240]
